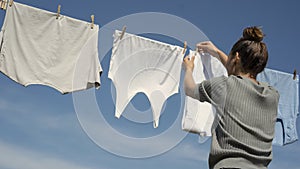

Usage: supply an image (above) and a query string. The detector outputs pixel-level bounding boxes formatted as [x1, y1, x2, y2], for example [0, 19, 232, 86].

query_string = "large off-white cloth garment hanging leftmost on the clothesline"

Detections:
[0, 2, 102, 94]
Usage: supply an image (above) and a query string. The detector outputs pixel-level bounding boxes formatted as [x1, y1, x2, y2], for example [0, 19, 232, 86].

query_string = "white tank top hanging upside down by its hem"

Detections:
[108, 30, 184, 128]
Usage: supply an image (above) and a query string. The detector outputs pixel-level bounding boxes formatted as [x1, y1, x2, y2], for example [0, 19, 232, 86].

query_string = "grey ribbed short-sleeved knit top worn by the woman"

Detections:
[196, 75, 279, 169]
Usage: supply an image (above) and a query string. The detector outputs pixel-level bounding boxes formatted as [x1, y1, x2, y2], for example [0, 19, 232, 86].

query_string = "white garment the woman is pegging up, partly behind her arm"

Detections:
[182, 50, 227, 136]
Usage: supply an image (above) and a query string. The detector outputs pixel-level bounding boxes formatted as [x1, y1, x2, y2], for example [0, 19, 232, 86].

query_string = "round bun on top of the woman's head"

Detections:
[242, 26, 265, 42]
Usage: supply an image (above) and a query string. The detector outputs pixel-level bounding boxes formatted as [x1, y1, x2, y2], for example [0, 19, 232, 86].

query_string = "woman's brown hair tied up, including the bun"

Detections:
[231, 26, 268, 77]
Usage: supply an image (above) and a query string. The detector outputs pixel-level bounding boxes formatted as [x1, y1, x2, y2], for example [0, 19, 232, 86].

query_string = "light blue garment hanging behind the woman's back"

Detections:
[257, 68, 299, 146]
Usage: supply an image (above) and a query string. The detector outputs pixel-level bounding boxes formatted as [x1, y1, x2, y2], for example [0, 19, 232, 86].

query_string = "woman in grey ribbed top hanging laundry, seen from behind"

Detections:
[184, 27, 279, 169]
